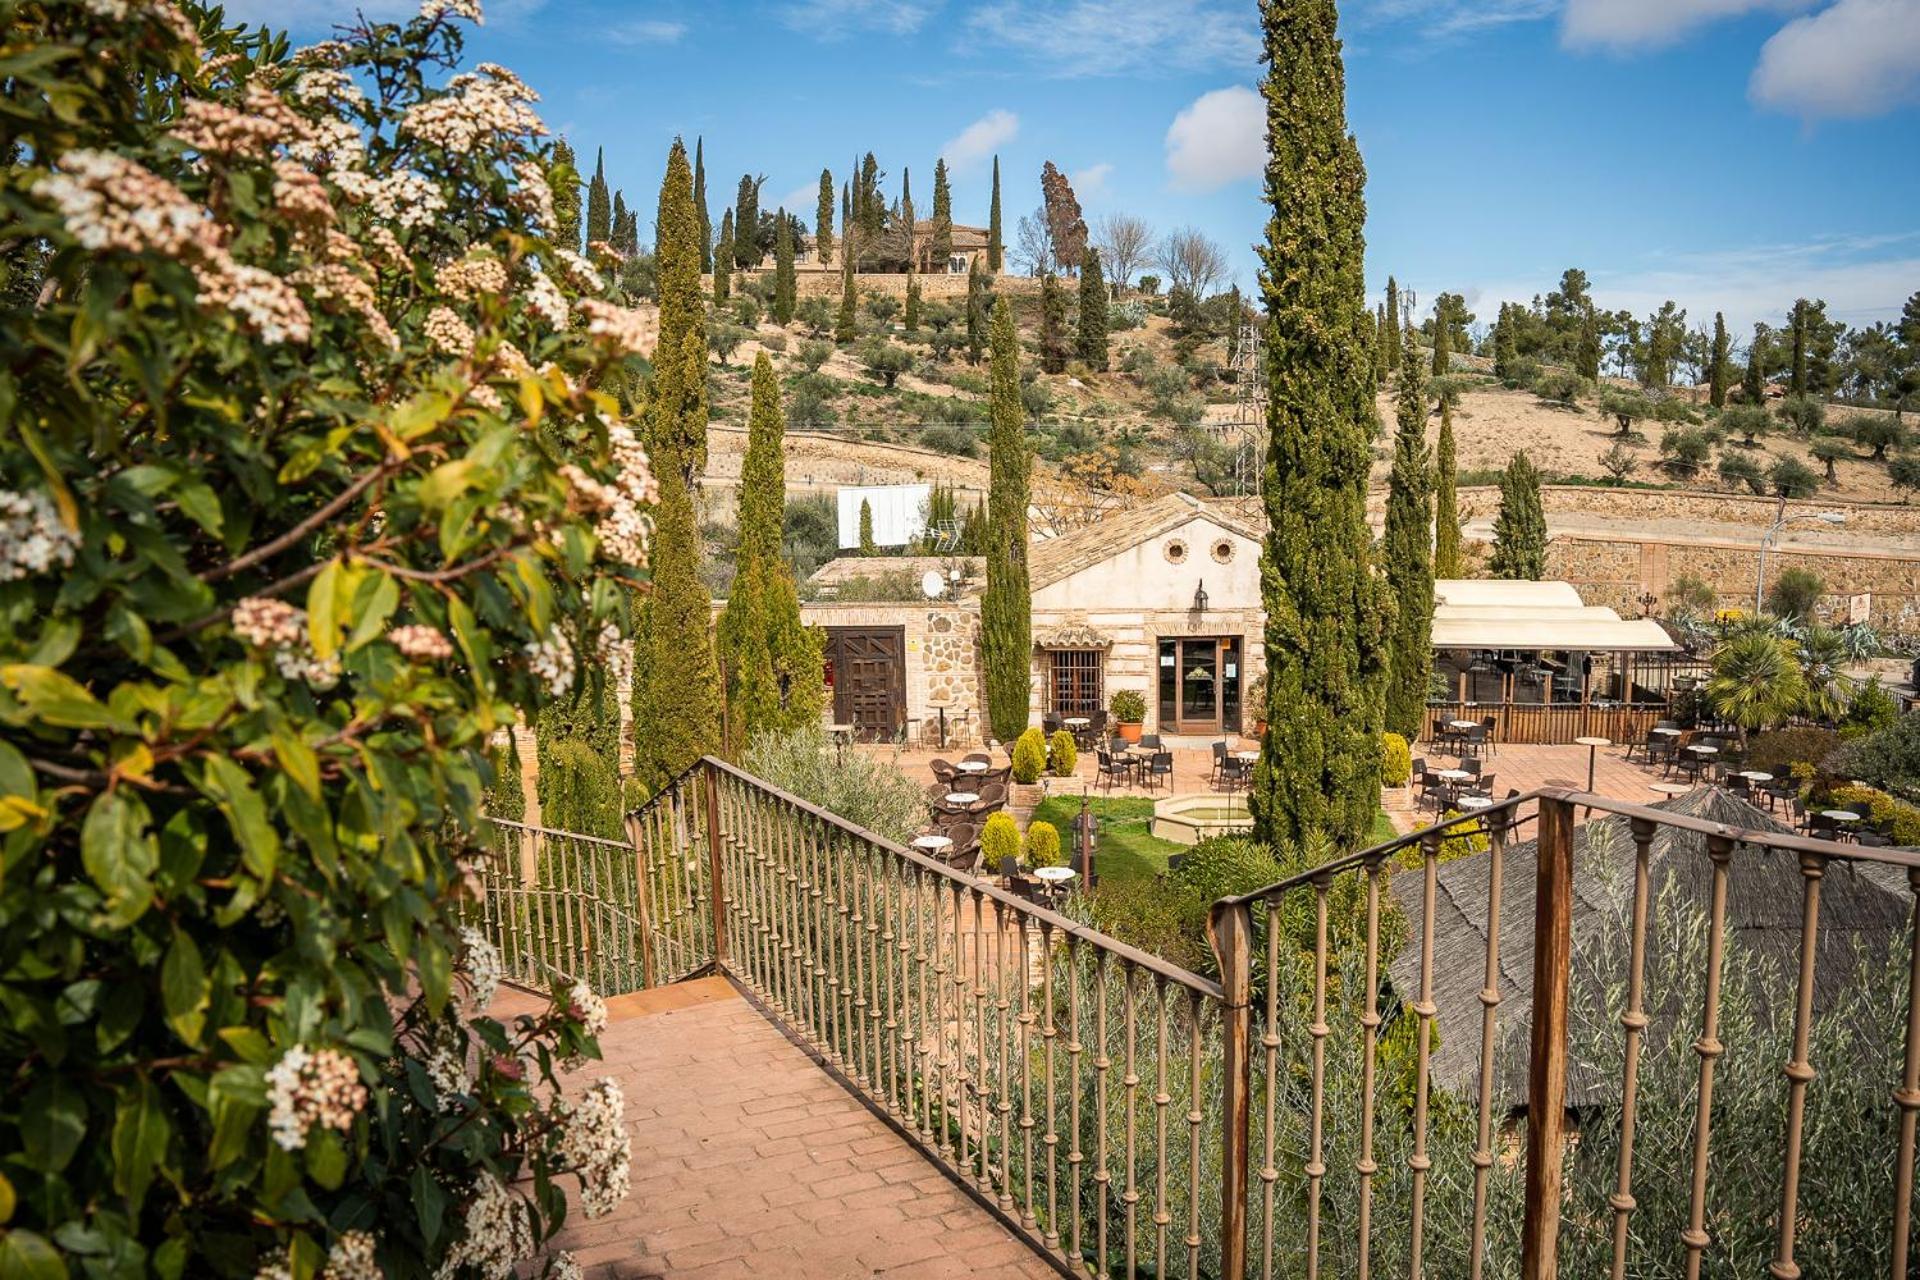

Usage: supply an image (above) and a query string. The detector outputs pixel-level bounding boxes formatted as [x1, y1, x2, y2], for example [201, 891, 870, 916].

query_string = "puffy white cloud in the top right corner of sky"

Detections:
[1747, 0, 1920, 117]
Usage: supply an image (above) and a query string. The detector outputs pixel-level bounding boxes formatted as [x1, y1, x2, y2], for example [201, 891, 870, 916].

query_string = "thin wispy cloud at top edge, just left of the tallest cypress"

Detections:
[968, 0, 1260, 77]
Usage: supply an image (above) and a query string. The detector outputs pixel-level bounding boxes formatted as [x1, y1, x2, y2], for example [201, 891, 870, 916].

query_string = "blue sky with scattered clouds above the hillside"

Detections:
[240, 0, 1920, 337]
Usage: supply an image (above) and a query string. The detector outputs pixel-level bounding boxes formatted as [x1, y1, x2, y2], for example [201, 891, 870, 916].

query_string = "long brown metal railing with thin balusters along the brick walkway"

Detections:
[486, 760, 1920, 1280]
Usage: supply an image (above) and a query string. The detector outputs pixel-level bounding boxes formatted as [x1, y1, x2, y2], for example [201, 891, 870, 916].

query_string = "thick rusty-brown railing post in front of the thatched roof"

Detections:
[1521, 798, 1572, 1280]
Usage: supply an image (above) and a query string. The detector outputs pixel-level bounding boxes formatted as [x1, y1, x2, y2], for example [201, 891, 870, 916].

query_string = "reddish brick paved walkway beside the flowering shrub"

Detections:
[526, 979, 1058, 1280]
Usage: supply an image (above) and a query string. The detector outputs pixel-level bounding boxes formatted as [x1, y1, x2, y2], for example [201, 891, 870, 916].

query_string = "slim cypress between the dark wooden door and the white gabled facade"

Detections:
[979, 297, 1033, 743]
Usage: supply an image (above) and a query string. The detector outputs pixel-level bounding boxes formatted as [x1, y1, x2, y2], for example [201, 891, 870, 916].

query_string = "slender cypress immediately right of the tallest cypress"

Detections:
[1380, 351, 1434, 743]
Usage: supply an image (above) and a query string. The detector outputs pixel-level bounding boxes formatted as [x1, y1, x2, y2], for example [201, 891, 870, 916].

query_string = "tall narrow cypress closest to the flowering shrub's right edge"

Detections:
[634, 138, 720, 791]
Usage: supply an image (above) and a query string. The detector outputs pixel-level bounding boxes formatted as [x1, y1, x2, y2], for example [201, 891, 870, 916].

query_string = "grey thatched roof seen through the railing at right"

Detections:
[1388, 787, 1912, 1105]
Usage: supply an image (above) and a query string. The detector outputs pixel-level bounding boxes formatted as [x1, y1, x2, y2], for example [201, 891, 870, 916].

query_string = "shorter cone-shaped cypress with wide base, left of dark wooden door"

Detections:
[718, 351, 824, 752]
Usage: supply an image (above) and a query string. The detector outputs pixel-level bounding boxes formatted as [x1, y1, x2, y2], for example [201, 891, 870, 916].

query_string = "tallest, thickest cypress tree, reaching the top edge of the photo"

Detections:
[1248, 0, 1390, 848]
